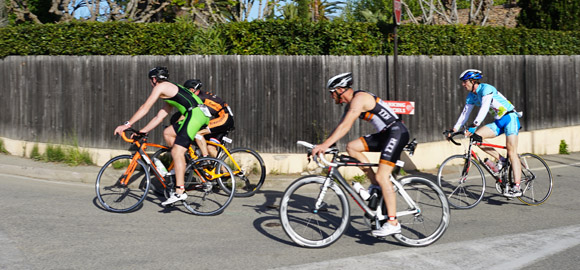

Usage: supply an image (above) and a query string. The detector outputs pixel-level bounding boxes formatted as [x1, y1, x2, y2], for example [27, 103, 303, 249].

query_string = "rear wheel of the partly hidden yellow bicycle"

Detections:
[220, 147, 266, 197]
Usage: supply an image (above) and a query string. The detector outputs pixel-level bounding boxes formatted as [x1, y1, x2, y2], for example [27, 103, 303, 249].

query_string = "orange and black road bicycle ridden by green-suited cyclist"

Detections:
[95, 129, 235, 216]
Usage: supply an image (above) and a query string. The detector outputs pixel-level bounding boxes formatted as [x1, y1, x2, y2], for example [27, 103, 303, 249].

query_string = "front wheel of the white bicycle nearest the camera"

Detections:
[280, 175, 350, 248]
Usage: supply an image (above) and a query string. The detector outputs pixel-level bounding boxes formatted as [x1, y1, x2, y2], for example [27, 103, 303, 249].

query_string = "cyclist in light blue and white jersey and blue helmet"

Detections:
[453, 69, 522, 197]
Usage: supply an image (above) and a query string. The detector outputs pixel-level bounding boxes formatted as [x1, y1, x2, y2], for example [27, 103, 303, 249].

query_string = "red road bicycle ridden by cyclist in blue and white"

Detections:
[437, 130, 552, 209]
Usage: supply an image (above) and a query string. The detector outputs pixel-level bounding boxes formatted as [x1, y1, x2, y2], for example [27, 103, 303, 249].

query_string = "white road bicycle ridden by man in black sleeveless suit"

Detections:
[280, 141, 450, 248]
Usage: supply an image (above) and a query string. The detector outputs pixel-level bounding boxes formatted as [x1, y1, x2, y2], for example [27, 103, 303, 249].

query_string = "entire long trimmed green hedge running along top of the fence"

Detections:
[0, 20, 580, 57]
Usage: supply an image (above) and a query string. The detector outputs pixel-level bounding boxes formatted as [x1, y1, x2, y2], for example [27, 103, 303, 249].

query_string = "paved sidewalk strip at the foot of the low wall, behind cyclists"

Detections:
[0, 154, 300, 191]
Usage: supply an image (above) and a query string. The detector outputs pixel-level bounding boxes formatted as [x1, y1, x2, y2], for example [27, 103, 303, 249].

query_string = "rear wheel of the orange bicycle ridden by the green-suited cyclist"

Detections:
[183, 157, 235, 216]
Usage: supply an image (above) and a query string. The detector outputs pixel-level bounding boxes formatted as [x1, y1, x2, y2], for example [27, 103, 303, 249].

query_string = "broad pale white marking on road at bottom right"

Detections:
[276, 225, 580, 270]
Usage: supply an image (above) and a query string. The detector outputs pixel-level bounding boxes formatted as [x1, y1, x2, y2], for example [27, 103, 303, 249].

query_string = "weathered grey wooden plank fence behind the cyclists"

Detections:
[0, 55, 580, 153]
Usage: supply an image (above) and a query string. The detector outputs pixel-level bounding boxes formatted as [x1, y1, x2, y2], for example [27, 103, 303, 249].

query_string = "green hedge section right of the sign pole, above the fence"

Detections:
[398, 25, 580, 55]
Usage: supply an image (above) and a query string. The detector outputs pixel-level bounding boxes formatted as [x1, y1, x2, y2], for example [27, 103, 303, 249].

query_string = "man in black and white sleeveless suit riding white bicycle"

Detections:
[312, 73, 409, 236]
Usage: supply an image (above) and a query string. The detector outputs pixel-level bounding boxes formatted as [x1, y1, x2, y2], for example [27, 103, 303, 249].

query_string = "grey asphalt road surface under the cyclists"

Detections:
[0, 153, 580, 269]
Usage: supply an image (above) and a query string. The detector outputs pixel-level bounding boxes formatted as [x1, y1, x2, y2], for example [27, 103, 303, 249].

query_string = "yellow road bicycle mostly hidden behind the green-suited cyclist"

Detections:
[153, 130, 266, 197]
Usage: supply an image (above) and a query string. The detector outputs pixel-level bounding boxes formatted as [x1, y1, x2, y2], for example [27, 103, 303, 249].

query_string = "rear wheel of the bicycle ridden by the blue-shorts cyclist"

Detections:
[509, 153, 553, 205]
